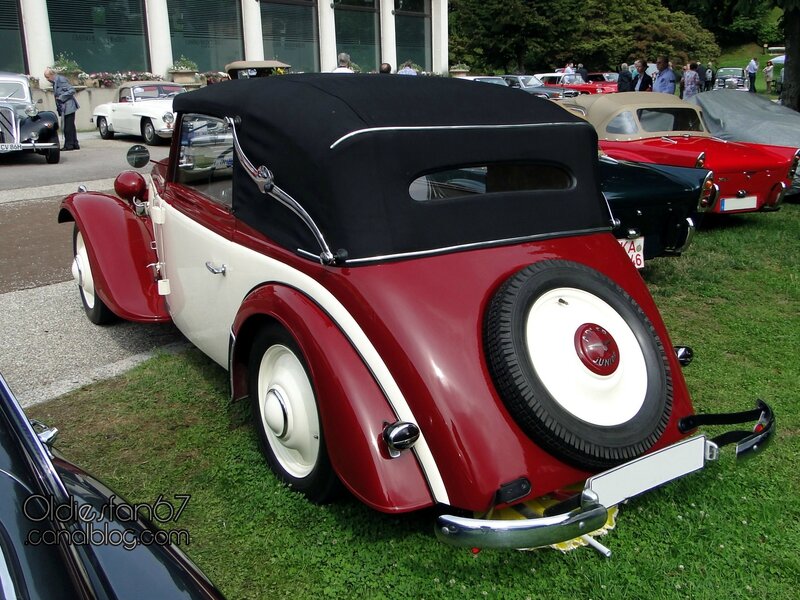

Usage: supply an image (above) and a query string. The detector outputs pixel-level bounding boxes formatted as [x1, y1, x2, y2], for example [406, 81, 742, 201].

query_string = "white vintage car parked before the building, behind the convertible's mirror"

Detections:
[92, 81, 186, 145]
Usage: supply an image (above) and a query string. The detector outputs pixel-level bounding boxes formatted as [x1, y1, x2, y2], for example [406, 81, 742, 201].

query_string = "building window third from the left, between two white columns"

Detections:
[167, 0, 244, 71]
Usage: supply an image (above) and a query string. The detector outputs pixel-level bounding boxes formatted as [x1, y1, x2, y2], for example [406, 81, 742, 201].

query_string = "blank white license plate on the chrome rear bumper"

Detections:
[586, 435, 706, 508]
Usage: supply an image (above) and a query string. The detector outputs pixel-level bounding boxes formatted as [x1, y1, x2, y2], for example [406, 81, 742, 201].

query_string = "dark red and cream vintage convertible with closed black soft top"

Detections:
[59, 74, 773, 548]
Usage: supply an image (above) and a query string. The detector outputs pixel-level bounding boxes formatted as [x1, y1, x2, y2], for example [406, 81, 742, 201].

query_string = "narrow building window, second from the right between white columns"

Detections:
[334, 0, 380, 73]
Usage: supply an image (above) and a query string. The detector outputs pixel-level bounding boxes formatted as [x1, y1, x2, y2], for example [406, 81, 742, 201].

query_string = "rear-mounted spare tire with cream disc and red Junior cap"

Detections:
[484, 260, 672, 471]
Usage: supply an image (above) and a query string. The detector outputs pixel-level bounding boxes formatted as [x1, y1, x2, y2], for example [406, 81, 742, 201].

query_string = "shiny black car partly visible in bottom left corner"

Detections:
[0, 375, 223, 600]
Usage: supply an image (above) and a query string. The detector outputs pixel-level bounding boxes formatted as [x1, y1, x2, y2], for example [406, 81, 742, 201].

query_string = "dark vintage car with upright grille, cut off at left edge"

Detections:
[0, 71, 61, 164]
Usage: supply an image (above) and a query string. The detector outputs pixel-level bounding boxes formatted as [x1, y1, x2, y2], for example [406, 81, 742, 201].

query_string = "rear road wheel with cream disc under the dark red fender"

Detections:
[248, 324, 339, 503]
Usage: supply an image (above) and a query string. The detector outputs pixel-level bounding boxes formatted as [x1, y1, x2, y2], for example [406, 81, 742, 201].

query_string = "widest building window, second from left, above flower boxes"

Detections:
[47, 0, 149, 73]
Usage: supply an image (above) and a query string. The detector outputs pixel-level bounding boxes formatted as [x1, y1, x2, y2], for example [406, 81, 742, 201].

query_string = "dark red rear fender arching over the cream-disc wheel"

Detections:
[230, 284, 434, 512]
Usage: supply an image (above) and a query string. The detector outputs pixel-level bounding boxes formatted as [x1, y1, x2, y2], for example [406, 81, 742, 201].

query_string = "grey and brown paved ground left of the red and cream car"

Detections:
[0, 134, 186, 406]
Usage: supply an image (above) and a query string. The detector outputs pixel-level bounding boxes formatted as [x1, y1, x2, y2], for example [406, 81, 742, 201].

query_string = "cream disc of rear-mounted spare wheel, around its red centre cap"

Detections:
[525, 288, 647, 426]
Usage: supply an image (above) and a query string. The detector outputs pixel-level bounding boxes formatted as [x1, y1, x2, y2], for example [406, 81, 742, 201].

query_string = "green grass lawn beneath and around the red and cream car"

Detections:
[28, 204, 800, 600]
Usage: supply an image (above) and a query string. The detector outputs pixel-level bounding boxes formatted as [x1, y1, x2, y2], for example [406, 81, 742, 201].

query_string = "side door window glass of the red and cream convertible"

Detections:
[175, 114, 233, 208]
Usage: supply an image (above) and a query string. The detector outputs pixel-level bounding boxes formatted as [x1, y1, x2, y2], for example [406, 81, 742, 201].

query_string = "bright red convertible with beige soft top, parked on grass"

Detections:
[562, 92, 800, 213]
